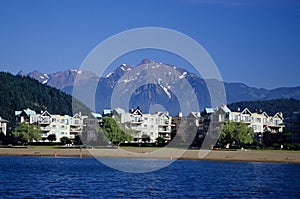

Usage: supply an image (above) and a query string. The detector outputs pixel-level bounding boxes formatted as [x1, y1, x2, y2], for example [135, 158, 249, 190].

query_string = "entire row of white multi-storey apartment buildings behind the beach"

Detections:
[0, 106, 290, 143]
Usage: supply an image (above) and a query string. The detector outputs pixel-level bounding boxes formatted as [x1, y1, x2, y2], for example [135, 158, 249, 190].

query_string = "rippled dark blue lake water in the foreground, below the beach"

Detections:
[0, 157, 300, 198]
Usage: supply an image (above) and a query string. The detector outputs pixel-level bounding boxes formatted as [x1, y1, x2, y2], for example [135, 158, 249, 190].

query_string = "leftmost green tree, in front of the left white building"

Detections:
[13, 123, 42, 144]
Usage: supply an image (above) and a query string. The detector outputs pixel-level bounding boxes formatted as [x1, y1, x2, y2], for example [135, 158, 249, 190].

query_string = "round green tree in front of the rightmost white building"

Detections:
[219, 121, 254, 145]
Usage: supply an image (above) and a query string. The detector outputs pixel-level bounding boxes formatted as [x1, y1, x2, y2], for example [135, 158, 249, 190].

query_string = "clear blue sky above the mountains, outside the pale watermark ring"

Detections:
[0, 0, 300, 88]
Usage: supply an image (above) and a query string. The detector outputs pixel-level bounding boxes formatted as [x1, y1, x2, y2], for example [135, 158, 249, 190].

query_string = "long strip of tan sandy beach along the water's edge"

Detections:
[0, 147, 300, 164]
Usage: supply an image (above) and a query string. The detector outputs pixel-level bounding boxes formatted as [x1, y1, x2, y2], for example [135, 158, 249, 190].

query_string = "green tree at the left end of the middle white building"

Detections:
[102, 117, 132, 144]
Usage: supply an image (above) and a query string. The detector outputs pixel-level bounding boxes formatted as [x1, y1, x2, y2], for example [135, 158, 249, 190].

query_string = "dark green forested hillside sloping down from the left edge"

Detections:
[0, 72, 88, 125]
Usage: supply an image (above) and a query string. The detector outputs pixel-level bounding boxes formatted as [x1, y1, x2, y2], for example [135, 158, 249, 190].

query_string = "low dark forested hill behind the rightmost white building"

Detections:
[228, 99, 300, 118]
